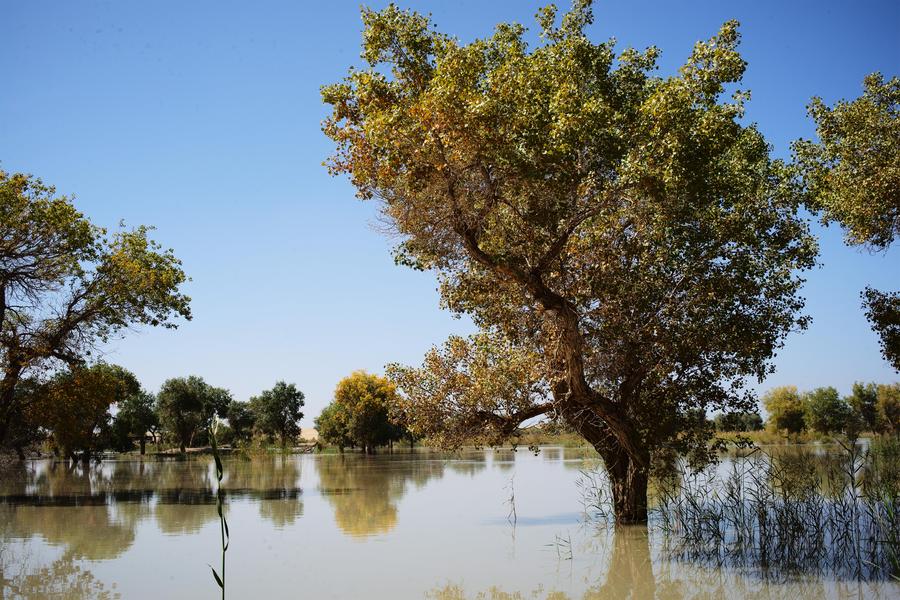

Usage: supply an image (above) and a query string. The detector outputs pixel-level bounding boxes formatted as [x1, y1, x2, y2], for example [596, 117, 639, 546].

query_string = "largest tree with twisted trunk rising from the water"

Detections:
[322, 0, 817, 522]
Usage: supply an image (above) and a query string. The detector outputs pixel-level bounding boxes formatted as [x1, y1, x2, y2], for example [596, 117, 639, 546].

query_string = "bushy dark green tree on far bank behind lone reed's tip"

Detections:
[156, 375, 231, 452]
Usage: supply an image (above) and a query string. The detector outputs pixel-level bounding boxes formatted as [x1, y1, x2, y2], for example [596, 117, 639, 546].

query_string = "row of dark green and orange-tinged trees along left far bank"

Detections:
[6, 363, 304, 461]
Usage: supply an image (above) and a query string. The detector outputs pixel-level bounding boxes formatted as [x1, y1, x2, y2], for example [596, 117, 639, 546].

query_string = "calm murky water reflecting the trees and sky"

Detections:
[0, 448, 900, 600]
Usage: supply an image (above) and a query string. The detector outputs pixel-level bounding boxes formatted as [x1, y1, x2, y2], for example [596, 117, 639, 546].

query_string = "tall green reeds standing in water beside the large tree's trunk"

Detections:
[579, 437, 900, 581]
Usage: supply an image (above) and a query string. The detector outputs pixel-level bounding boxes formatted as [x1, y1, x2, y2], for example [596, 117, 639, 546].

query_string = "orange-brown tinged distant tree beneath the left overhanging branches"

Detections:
[34, 363, 140, 462]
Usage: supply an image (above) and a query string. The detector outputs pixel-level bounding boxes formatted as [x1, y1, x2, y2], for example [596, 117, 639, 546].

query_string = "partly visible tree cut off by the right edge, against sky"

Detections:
[794, 73, 900, 371]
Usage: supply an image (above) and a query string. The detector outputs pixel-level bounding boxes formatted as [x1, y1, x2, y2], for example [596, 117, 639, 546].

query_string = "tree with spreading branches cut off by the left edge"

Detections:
[0, 171, 191, 443]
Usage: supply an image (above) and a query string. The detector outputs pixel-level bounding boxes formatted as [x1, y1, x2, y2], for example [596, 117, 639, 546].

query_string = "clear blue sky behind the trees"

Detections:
[0, 0, 900, 427]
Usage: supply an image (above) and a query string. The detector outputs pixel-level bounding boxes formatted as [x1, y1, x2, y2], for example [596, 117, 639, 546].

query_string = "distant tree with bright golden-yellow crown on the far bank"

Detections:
[334, 371, 403, 454]
